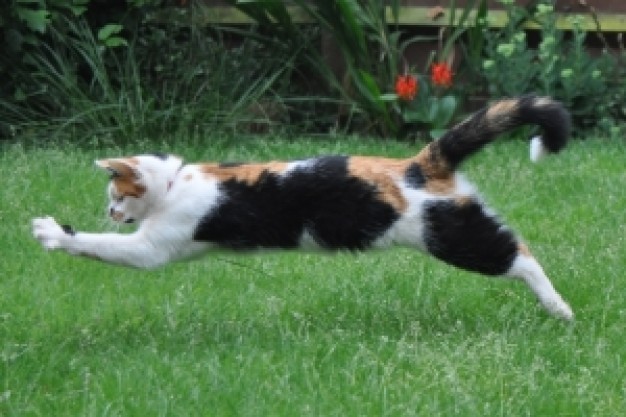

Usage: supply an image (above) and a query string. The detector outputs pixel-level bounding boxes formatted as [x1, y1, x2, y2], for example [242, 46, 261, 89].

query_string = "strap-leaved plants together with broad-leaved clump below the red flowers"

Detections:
[230, 0, 475, 140]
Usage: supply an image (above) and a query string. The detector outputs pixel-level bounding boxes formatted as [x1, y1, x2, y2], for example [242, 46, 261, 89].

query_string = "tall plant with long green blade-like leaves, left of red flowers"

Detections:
[224, 0, 395, 130]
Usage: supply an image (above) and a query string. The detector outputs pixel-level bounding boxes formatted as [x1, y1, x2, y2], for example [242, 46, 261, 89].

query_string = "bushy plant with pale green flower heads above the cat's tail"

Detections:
[470, 0, 617, 130]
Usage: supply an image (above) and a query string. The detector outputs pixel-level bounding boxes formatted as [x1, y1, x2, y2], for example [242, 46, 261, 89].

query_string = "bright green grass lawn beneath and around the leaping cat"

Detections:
[0, 138, 626, 416]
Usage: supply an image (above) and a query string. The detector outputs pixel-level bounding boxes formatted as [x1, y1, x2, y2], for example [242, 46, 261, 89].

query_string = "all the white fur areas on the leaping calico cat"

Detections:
[33, 154, 573, 320]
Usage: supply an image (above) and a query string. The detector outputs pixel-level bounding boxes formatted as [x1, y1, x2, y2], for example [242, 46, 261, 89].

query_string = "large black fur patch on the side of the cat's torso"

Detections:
[194, 156, 399, 250]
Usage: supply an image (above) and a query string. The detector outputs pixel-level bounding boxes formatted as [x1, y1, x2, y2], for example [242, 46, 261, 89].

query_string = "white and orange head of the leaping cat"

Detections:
[96, 154, 182, 223]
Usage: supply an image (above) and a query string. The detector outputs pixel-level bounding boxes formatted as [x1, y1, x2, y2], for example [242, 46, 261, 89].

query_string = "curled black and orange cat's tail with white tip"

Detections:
[427, 95, 570, 171]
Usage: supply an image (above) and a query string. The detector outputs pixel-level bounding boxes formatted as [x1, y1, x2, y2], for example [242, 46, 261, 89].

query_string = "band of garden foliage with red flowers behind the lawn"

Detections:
[0, 0, 626, 139]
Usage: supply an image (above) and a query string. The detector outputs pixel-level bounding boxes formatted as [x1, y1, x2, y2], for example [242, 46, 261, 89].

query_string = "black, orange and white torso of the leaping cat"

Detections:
[183, 155, 470, 249]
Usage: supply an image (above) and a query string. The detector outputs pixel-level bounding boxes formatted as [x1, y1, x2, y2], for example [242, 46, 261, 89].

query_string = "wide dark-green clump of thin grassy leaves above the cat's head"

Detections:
[0, 1, 289, 141]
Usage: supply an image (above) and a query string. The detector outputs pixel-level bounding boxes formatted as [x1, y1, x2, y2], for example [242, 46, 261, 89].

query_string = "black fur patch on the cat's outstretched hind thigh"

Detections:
[424, 200, 518, 275]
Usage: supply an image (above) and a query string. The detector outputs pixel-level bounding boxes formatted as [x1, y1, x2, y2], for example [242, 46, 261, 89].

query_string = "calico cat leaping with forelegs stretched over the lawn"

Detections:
[33, 95, 573, 320]
